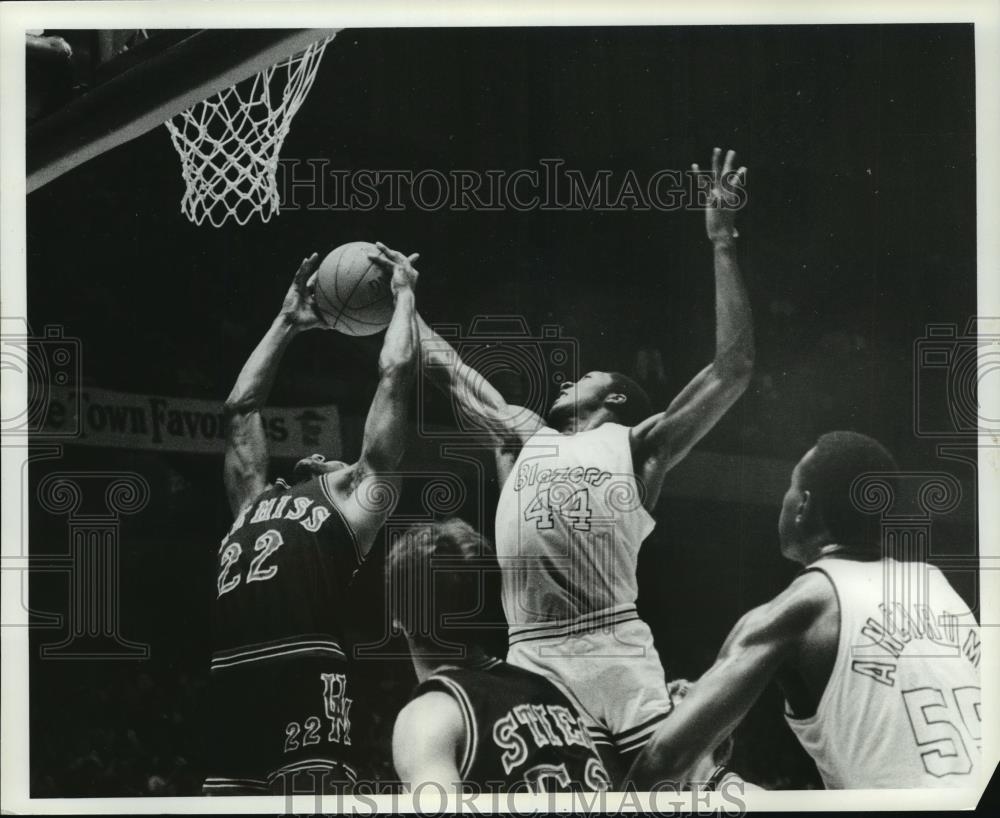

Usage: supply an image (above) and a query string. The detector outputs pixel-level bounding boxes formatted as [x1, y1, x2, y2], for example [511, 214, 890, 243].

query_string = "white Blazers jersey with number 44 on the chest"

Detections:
[496, 423, 655, 634]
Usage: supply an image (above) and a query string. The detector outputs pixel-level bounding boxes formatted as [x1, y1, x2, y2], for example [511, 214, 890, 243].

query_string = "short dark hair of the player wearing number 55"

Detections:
[799, 432, 899, 549]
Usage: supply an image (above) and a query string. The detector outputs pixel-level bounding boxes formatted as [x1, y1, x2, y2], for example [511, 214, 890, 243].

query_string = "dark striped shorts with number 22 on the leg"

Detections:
[202, 635, 361, 795]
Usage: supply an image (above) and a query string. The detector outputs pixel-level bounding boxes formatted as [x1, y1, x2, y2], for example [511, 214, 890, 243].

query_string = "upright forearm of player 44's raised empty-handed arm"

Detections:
[712, 239, 755, 380]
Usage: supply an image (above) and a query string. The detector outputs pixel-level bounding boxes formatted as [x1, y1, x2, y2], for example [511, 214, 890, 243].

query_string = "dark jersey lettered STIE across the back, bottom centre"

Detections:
[413, 659, 610, 792]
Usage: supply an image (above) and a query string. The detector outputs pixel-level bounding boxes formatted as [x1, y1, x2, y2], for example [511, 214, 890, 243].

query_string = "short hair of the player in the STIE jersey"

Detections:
[386, 517, 496, 646]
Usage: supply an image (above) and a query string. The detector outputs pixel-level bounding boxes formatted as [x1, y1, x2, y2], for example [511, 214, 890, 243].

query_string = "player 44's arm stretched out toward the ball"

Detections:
[372, 242, 544, 445]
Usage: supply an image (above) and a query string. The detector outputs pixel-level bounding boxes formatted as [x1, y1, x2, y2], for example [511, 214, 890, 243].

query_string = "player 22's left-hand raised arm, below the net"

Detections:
[223, 253, 328, 515]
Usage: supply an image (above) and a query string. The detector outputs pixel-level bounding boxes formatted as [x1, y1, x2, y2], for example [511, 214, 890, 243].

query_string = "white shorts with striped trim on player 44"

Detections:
[507, 605, 673, 754]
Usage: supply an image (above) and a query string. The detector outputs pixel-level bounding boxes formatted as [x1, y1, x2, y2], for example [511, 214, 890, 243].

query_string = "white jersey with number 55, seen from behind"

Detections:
[786, 557, 983, 789]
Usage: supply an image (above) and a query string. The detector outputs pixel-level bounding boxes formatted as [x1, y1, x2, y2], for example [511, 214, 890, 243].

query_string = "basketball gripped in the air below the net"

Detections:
[316, 241, 392, 335]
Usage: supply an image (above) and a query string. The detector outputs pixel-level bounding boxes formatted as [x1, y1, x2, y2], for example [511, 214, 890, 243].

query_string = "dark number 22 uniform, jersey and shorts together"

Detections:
[205, 478, 362, 794]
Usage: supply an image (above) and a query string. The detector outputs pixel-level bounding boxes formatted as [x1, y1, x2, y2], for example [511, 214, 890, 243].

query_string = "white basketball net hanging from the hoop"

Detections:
[166, 37, 333, 227]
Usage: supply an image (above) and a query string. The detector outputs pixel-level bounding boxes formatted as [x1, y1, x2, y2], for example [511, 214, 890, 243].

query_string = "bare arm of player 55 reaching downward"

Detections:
[628, 571, 833, 790]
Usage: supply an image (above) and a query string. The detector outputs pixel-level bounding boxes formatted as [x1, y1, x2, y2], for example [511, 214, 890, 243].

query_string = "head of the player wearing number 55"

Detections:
[778, 432, 899, 563]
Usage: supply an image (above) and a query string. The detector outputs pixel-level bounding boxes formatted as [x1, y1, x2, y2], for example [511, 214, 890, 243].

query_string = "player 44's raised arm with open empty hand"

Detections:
[631, 148, 754, 508]
